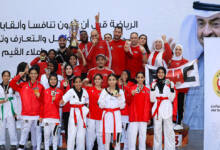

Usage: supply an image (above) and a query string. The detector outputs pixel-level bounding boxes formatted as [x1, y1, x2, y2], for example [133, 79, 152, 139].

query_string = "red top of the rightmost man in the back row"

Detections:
[126, 46, 144, 79]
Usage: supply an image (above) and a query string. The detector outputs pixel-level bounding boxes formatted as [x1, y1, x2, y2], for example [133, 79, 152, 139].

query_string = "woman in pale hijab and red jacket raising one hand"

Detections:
[147, 35, 172, 67]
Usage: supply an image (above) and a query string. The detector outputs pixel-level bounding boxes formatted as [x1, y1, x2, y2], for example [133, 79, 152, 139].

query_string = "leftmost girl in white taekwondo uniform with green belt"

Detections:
[0, 70, 18, 150]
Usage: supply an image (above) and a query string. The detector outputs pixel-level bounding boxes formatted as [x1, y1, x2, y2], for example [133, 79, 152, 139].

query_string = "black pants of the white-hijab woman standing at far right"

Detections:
[177, 93, 185, 124]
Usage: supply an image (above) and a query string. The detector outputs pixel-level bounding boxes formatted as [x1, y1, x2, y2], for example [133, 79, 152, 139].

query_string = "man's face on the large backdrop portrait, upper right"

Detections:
[197, 13, 220, 45]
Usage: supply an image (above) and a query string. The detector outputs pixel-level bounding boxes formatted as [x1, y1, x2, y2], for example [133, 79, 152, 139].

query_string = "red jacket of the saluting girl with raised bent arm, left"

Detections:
[10, 75, 44, 116]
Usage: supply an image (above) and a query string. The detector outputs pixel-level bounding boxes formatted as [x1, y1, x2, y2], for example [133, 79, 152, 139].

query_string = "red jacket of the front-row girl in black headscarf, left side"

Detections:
[41, 87, 63, 119]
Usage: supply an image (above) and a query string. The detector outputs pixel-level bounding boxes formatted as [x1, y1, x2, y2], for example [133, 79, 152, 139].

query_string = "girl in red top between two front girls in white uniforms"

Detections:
[86, 74, 104, 150]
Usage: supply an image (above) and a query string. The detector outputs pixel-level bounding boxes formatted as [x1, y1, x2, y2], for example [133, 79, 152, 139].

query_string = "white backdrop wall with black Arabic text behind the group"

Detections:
[0, 0, 193, 76]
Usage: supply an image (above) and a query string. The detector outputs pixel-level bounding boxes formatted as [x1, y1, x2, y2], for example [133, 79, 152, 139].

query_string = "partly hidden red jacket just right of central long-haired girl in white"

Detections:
[119, 81, 134, 116]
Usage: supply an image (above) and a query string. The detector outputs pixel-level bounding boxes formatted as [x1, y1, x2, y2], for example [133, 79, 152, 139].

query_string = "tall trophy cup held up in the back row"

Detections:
[70, 19, 79, 49]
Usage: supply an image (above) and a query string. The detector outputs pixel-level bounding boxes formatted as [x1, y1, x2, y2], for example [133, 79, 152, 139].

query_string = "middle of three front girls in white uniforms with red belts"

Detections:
[98, 74, 125, 150]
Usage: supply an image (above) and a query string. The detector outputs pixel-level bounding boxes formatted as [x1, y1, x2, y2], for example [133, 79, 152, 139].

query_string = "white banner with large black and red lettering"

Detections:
[145, 60, 200, 89]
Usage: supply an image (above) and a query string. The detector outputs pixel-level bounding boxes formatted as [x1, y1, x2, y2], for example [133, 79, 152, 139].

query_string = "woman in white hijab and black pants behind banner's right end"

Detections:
[169, 44, 189, 130]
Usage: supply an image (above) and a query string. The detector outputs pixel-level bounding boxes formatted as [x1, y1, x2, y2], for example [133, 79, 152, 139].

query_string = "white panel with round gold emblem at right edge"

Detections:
[204, 38, 220, 150]
